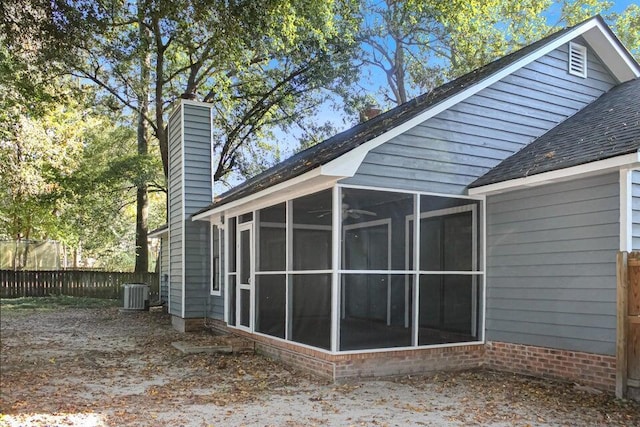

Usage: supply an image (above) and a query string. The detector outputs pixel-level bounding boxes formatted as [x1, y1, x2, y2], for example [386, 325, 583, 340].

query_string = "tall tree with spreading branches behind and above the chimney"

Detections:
[4, 0, 355, 269]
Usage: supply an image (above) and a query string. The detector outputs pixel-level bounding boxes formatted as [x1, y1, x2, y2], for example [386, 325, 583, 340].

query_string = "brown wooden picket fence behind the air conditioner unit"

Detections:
[0, 270, 159, 302]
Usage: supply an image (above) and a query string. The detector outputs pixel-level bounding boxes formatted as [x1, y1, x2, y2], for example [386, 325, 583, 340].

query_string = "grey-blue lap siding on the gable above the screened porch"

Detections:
[342, 45, 616, 194]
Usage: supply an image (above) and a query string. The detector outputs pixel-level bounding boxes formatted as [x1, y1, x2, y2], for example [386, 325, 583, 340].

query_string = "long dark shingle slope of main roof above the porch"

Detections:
[196, 16, 584, 214]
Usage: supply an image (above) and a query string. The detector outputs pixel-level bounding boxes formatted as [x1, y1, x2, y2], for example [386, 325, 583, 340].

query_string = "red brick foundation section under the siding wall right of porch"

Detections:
[485, 342, 616, 392]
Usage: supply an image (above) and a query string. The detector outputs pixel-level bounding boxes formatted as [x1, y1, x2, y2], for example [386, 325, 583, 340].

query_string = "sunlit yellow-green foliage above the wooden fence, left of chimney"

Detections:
[0, 50, 165, 270]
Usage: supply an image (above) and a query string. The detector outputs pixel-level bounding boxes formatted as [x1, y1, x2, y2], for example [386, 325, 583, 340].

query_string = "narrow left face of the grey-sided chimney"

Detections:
[168, 111, 184, 316]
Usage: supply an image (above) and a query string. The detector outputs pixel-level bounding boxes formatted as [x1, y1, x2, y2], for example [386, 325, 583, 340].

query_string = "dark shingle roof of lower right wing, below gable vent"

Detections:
[470, 79, 640, 187]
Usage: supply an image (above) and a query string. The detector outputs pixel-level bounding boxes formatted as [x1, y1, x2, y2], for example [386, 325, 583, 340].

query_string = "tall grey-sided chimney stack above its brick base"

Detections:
[169, 103, 224, 318]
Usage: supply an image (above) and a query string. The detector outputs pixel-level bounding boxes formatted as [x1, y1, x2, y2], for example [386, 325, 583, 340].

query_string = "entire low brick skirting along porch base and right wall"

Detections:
[191, 319, 616, 392]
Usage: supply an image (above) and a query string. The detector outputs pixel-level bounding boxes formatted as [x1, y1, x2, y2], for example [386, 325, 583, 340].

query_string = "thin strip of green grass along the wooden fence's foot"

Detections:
[0, 295, 121, 311]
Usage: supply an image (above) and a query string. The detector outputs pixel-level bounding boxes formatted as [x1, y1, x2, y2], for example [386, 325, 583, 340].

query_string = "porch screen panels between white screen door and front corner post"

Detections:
[250, 190, 332, 350]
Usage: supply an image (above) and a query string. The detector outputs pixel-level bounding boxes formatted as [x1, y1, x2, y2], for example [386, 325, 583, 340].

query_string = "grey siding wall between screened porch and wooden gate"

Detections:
[486, 173, 620, 355]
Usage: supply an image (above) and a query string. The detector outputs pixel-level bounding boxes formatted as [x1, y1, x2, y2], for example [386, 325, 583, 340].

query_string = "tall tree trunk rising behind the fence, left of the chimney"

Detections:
[135, 0, 151, 273]
